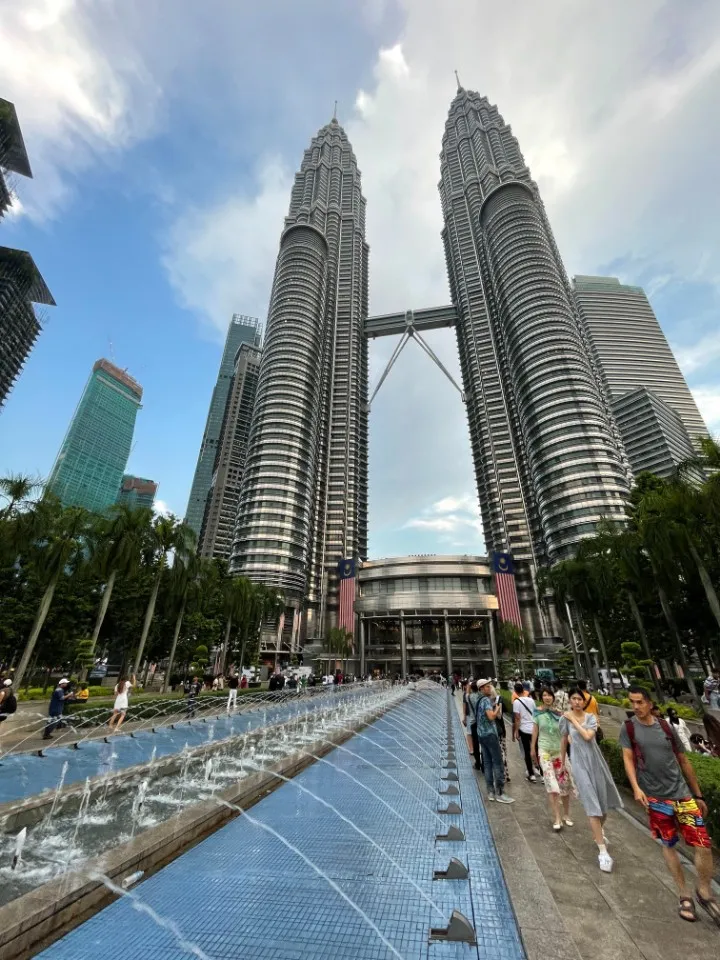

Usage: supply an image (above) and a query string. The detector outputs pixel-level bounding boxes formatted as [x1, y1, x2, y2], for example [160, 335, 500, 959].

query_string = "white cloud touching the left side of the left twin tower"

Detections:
[163, 158, 292, 337]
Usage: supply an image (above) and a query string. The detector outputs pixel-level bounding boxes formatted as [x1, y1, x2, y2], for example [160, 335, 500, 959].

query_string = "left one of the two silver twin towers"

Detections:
[232, 118, 368, 637]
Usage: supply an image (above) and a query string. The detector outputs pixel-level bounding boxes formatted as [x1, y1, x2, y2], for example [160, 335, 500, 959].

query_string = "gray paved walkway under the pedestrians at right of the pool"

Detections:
[456, 696, 720, 960]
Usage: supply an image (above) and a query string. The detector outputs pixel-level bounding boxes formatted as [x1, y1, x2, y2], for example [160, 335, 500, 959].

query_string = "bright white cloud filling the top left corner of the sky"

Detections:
[0, 0, 160, 220]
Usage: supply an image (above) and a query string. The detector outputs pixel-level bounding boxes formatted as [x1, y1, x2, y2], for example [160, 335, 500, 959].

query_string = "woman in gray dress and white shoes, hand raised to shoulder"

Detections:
[560, 690, 623, 873]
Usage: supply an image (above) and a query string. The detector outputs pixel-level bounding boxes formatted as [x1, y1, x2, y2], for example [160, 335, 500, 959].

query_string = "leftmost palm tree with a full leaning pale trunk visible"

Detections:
[15, 496, 89, 689]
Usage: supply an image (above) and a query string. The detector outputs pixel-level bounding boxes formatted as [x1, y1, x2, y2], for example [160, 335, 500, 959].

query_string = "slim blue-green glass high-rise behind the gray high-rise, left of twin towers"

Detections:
[185, 313, 262, 537]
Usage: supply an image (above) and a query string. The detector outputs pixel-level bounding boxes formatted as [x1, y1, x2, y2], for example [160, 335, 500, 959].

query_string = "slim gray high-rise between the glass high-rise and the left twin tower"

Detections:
[198, 343, 261, 560]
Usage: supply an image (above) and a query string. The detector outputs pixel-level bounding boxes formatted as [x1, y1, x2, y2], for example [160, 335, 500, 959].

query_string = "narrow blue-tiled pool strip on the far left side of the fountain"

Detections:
[0, 686, 374, 804]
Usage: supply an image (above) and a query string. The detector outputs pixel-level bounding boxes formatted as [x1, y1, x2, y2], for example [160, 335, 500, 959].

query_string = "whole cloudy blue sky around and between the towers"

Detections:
[0, 0, 720, 557]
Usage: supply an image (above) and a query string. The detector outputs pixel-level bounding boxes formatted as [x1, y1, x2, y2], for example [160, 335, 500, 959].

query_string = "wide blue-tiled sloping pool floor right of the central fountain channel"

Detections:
[40, 690, 525, 960]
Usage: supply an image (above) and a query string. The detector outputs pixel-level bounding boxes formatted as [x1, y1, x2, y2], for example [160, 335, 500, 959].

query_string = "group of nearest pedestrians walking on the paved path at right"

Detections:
[461, 678, 720, 927]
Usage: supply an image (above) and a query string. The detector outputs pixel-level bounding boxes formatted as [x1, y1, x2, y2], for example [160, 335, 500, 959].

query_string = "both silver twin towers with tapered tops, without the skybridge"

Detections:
[231, 87, 629, 639]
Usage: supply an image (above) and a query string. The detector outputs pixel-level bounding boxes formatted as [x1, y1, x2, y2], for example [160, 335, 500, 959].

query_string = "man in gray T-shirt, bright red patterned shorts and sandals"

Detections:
[620, 686, 720, 927]
